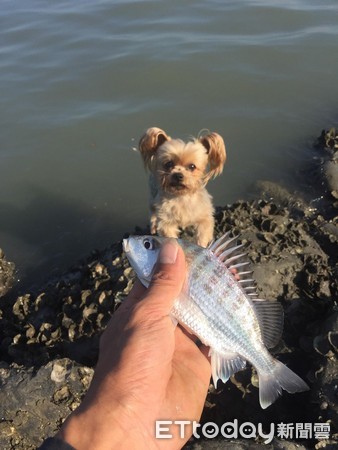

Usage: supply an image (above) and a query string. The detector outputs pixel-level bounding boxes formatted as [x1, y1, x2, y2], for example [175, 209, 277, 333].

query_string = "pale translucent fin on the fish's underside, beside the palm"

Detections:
[209, 349, 246, 388]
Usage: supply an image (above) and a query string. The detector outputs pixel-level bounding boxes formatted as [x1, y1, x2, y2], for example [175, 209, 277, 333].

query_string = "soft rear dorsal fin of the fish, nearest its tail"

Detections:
[251, 299, 284, 348]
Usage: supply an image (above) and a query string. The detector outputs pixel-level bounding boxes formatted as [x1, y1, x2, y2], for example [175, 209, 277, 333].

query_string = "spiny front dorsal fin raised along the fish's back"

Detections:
[208, 232, 258, 298]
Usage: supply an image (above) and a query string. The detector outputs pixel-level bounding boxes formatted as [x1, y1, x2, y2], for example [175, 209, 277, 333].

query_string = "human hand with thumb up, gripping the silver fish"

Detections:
[57, 240, 211, 450]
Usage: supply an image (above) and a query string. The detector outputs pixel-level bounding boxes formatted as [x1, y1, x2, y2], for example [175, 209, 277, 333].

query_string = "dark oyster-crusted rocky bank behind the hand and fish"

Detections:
[0, 130, 338, 450]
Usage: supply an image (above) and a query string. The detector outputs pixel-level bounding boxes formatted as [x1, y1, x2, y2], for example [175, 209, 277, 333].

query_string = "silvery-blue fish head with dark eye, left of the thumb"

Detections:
[123, 236, 163, 287]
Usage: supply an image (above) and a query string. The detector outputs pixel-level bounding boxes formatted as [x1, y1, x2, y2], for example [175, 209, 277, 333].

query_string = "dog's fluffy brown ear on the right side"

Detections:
[199, 133, 226, 182]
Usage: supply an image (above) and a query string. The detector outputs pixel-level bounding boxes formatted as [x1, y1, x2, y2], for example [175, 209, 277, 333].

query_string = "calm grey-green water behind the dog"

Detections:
[0, 0, 338, 288]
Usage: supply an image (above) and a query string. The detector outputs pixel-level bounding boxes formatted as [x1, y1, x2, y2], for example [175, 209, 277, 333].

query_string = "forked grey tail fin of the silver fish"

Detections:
[258, 359, 309, 409]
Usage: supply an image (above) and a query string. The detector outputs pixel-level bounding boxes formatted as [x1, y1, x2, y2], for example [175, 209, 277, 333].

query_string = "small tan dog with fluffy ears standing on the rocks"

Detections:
[139, 127, 226, 247]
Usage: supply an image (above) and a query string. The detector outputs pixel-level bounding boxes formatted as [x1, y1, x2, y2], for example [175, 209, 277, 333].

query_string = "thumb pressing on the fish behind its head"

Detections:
[143, 238, 186, 315]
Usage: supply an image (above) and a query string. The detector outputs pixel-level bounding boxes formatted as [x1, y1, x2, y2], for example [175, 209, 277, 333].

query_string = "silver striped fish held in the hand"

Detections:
[123, 233, 309, 409]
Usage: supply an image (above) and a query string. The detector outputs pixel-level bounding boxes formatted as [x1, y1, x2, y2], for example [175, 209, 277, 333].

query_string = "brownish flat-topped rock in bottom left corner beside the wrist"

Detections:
[0, 360, 90, 450]
